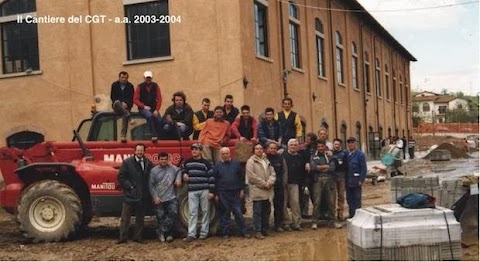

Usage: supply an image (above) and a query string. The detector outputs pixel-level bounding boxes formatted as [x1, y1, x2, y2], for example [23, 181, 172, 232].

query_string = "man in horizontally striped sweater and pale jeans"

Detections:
[183, 143, 215, 242]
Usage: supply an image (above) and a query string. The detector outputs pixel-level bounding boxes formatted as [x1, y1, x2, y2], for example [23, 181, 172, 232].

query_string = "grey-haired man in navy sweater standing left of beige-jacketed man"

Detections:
[213, 147, 250, 238]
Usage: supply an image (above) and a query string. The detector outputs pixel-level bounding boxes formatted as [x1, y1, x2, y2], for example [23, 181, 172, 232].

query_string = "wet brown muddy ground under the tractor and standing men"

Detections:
[0, 137, 479, 261]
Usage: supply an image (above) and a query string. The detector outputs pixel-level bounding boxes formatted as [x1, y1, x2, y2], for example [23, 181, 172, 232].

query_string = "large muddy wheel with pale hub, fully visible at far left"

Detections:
[17, 180, 82, 243]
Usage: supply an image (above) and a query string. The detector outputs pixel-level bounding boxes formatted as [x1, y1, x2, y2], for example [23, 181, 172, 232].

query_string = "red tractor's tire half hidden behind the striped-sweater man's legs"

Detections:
[177, 185, 220, 235]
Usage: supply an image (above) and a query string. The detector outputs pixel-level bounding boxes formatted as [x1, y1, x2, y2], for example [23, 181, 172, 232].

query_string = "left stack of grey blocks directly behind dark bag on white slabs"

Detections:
[390, 176, 440, 204]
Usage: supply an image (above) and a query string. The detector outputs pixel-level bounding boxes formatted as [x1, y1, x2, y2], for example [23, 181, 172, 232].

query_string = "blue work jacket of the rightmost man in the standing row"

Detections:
[346, 148, 367, 187]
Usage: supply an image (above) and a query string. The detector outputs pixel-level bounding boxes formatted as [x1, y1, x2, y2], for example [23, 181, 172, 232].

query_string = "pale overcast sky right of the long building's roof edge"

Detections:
[357, 0, 480, 95]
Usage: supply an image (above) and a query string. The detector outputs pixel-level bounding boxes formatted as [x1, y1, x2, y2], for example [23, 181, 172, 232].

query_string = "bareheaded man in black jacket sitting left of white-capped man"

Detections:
[110, 71, 133, 142]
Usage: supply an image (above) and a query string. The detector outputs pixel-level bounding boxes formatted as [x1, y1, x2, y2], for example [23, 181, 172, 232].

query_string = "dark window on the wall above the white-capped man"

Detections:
[124, 0, 171, 60]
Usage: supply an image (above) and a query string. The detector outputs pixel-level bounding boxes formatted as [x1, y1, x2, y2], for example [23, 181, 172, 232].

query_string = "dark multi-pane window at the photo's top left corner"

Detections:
[0, 0, 40, 74]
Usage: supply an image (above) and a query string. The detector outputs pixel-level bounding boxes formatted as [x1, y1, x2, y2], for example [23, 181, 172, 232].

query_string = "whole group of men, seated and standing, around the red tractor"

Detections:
[112, 71, 367, 243]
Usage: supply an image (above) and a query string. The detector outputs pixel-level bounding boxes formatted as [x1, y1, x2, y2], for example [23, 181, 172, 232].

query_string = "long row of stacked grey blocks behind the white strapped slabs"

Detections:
[390, 176, 469, 208]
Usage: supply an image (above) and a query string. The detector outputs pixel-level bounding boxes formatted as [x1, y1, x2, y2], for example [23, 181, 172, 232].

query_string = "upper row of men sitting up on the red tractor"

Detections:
[110, 71, 302, 146]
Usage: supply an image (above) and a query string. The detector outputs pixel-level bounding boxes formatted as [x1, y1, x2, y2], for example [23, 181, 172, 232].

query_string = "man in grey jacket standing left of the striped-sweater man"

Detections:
[148, 152, 182, 242]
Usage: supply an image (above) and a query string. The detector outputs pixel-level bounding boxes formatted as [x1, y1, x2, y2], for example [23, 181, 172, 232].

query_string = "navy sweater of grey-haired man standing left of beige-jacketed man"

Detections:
[213, 160, 245, 191]
